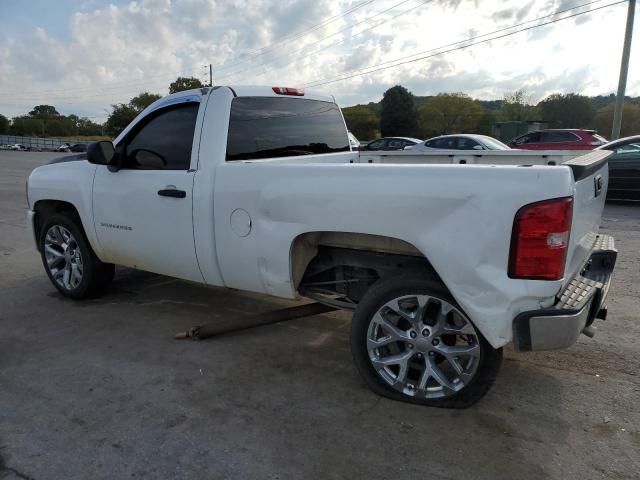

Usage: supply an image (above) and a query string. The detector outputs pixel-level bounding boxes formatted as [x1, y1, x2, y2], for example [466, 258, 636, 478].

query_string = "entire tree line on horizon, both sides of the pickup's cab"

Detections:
[0, 77, 640, 140]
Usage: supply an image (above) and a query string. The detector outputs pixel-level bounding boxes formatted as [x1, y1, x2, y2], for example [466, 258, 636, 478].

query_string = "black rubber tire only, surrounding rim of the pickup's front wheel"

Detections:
[38, 212, 115, 300]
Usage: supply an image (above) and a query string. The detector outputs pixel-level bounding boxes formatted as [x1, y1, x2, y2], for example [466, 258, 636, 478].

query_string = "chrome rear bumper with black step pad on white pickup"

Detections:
[513, 235, 617, 351]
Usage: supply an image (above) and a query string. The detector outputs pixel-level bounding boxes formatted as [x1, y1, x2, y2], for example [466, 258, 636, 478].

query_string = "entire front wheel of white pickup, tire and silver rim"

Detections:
[38, 213, 115, 299]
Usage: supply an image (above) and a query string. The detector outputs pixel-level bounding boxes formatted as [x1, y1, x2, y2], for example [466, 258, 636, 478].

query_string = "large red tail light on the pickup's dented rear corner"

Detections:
[509, 197, 573, 280]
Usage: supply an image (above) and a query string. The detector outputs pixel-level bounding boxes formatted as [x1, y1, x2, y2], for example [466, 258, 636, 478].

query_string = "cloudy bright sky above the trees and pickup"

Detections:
[0, 0, 640, 121]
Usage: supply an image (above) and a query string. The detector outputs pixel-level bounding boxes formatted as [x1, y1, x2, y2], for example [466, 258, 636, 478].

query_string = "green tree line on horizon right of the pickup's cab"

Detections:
[342, 85, 640, 140]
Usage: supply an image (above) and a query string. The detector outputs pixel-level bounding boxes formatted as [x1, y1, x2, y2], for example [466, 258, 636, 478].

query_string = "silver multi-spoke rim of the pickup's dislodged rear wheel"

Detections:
[367, 295, 480, 399]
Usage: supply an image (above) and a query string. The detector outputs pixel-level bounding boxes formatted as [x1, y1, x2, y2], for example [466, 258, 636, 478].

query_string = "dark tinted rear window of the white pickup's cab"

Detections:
[227, 97, 349, 160]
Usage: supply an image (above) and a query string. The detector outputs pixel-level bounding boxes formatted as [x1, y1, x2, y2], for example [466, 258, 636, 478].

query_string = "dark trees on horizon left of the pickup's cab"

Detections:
[0, 77, 204, 137]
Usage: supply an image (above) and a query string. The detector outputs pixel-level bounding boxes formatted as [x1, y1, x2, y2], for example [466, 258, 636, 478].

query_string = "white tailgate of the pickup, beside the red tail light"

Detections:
[563, 150, 612, 279]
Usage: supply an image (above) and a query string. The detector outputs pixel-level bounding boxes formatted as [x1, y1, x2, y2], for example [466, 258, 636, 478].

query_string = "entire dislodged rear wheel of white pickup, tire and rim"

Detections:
[351, 276, 502, 408]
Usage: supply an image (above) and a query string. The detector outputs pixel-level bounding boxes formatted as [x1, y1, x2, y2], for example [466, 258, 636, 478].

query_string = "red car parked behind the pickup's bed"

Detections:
[508, 128, 607, 150]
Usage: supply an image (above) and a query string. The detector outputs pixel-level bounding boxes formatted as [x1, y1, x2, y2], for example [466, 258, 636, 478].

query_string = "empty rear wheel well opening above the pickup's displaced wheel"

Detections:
[291, 232, 446, 306]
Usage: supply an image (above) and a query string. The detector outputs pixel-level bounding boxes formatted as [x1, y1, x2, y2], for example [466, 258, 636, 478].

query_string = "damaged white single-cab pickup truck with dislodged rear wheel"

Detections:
[27, 86, 616, 408]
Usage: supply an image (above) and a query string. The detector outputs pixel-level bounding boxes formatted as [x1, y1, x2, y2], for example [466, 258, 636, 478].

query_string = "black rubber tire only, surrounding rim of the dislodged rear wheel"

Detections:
[351, 276, 502, 408]
